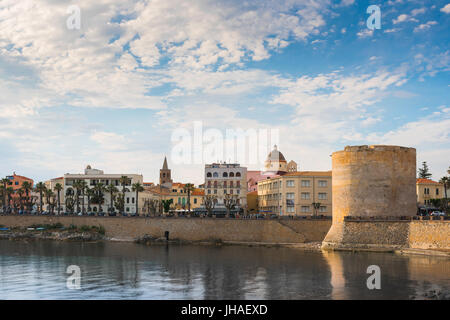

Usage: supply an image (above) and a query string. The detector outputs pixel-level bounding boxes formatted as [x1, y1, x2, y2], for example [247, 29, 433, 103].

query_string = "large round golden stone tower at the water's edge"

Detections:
[323, 145, 417, 247]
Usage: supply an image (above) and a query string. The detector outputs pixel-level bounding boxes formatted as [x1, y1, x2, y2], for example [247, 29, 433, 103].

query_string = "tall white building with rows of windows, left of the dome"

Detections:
[205, 163, 247, 209]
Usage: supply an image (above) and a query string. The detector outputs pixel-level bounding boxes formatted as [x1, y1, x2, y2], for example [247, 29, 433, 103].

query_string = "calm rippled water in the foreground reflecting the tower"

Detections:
[0, 240, 450, 299]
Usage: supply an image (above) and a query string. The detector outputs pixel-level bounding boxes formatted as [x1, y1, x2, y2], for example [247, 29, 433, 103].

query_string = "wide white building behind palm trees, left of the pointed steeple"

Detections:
[62, 165, 143, 214]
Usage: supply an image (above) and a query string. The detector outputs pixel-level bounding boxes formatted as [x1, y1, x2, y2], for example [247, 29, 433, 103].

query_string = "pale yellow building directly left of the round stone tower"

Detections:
[258, 171, 332, 216]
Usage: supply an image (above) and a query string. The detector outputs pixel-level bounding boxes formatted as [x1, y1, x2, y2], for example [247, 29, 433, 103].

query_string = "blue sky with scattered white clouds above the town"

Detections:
[0, 0, 450, 184]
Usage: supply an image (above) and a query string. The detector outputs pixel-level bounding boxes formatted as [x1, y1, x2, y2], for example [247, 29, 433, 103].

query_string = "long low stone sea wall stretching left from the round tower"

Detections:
[0, 216, 331, 244]
